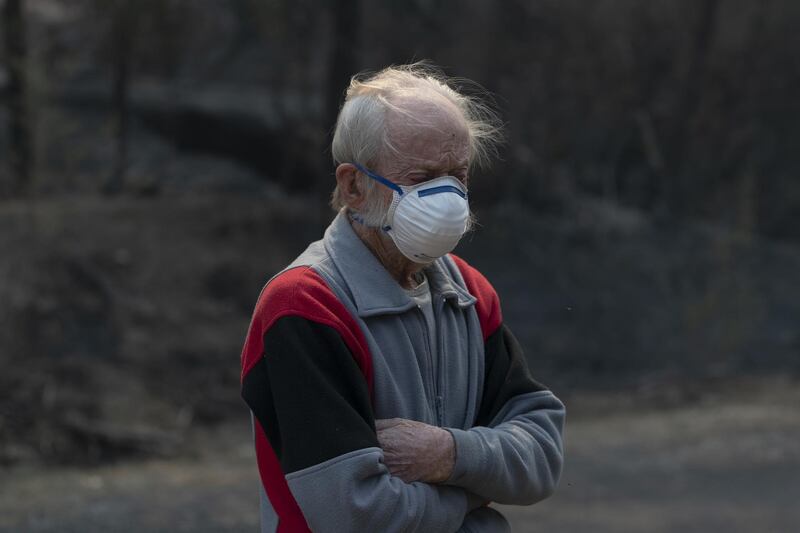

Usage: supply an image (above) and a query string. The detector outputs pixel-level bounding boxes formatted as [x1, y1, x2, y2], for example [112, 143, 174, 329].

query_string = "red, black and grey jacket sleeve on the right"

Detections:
[447, 258, 565, 505]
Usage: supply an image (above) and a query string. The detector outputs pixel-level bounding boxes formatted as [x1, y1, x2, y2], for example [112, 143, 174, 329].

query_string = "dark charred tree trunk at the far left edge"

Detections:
[2, 0, 33, 194]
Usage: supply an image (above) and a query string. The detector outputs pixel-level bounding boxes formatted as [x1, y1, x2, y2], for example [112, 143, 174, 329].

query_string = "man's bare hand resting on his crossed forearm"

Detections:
[375, 418, 456, 483]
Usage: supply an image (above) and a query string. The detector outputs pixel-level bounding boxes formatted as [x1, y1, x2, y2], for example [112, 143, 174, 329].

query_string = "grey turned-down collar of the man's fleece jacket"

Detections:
[323, 209, 476, 317]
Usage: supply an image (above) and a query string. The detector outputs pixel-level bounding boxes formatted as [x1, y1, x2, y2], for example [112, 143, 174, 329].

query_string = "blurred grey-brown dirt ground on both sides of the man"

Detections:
[0, 379, 800, 533]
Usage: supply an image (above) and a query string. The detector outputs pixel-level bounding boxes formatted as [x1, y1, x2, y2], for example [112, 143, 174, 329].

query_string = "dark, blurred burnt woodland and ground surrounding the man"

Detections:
[0, 0, 800, 532]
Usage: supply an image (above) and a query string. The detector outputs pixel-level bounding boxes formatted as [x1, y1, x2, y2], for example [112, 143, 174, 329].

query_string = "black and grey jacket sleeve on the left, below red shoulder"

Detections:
[242, 270, 480, 532]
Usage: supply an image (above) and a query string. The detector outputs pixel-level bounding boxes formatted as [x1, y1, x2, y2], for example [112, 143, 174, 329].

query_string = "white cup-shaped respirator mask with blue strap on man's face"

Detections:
[353, 163, 469, 263]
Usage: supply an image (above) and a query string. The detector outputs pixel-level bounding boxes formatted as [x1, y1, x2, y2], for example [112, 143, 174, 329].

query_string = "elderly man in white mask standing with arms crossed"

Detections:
[242, 65, 564, 533]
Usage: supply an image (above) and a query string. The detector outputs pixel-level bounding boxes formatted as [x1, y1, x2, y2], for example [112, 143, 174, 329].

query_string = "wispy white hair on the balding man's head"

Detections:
[331, 63, 502, 211]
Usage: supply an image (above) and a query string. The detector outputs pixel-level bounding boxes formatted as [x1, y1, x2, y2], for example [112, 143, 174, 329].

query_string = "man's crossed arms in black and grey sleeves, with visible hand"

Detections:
[242, 316, 564, 531]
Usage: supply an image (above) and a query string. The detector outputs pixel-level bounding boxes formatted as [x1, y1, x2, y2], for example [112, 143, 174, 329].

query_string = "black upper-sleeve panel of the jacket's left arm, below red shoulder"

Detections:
[242, 316, 378, 474]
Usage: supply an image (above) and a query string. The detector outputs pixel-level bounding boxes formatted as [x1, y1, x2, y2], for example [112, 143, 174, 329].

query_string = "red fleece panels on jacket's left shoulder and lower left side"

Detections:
[241, 266, 373, 533]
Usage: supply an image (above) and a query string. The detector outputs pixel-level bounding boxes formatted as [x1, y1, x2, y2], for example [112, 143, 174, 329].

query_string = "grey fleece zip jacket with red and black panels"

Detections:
[242, 213, 565, 533]
